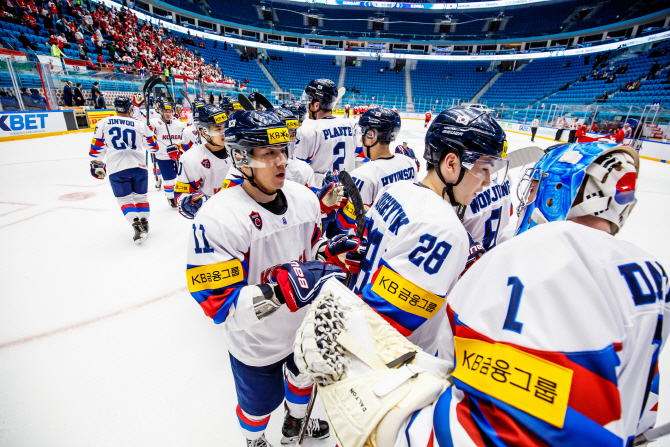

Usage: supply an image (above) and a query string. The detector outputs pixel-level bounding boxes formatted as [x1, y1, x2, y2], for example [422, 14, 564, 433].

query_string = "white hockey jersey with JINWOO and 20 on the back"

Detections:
[89, 116, 158, 175]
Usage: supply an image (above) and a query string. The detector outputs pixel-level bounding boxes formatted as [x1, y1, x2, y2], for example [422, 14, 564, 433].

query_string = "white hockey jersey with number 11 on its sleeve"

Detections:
[186, 182, 321, 366]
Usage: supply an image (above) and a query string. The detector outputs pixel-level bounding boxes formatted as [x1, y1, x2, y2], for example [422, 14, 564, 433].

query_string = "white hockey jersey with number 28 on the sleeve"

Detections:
[355, 180, 470, 354]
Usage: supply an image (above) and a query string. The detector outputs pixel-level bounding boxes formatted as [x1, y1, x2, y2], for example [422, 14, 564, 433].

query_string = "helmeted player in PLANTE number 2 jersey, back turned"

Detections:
[295, 79, 356, 183]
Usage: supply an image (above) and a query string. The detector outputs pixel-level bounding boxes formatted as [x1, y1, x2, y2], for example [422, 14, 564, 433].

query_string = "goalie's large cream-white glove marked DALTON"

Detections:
[294, 279, 450, 447]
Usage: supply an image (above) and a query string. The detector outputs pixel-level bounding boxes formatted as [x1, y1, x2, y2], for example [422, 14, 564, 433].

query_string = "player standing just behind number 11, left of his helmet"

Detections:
[174, 104, 232, 219]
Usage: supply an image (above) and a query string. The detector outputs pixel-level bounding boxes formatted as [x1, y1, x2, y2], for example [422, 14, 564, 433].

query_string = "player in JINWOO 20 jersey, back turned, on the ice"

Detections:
[89, 96, 157, 244]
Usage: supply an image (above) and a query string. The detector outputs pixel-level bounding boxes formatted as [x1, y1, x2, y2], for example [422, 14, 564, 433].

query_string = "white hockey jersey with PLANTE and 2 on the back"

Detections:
[295, 116, 356, 184]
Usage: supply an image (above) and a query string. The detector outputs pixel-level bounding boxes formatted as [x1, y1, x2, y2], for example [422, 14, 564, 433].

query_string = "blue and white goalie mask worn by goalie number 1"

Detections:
[517, 143, 640, 234]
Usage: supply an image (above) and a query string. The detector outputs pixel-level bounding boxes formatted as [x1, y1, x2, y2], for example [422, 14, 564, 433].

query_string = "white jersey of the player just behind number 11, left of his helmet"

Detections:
[174, 144, 232, 201]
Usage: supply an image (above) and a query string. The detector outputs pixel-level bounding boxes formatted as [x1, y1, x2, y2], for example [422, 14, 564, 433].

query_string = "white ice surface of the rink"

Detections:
[0, 120, 670, 447]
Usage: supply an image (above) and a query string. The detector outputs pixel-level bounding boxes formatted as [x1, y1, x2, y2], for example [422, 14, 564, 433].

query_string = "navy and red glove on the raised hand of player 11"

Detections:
[274, 261, 345, 312]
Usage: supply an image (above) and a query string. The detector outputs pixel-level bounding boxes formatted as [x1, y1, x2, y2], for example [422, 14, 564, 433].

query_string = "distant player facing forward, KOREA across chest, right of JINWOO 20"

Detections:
[151, 98, 185, 208]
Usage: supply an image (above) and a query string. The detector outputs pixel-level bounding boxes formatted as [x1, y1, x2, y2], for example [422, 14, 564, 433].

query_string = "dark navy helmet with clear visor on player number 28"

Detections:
[423, 106, 507, 205]
